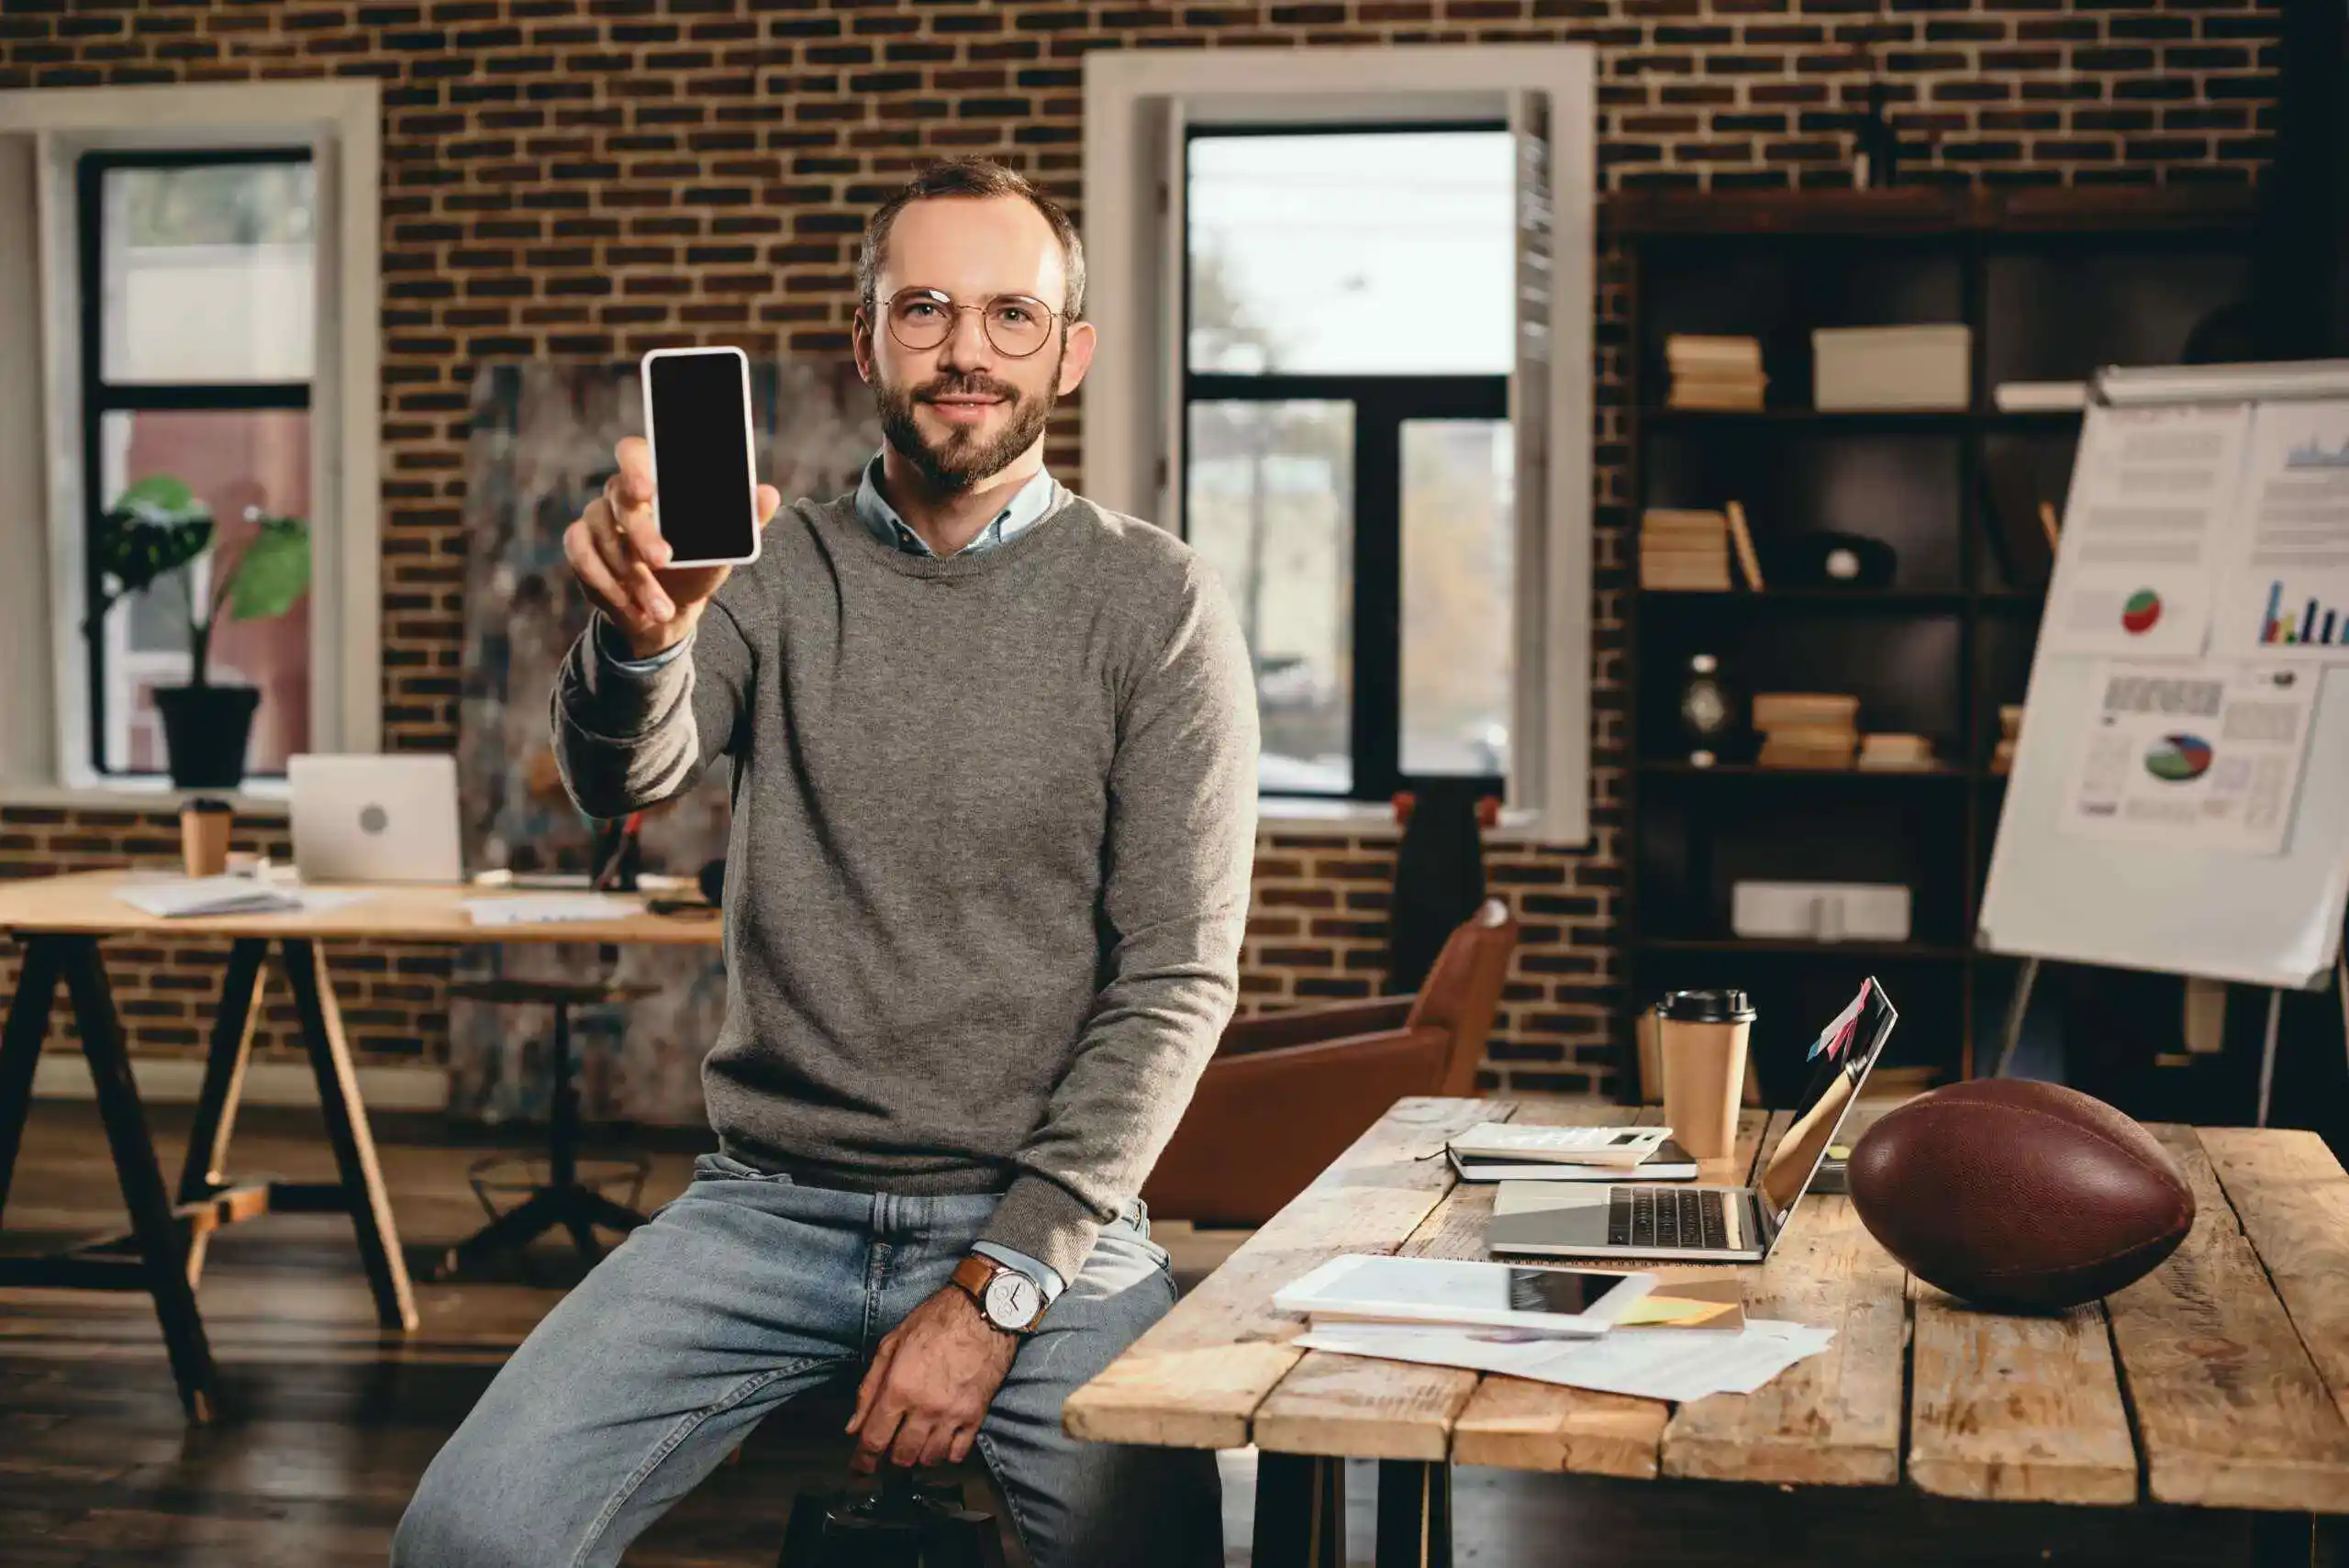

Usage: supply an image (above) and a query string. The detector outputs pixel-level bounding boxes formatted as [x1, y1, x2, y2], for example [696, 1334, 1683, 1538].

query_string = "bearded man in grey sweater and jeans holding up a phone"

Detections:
[393, 162, 1257, 1568]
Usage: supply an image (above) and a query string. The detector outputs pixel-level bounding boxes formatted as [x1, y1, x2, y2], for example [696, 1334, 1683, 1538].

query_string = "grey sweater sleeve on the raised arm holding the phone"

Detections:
[552, 591, 756, 819]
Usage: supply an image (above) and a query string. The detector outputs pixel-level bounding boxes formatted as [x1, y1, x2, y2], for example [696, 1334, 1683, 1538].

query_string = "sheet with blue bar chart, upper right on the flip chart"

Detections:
[2210, 401, 2349, 662]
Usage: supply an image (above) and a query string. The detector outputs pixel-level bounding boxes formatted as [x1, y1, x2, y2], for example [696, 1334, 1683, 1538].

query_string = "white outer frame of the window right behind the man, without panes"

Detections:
[1083, 45, 1598, 845]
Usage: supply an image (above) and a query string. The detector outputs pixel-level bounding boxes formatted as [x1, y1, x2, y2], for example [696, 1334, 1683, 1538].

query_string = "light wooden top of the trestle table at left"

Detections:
[0, 871, 723, 946]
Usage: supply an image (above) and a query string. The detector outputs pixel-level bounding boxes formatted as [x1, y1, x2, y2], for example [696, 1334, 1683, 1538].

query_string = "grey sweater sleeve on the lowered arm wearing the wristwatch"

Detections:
[980, 559, 1257, 1279]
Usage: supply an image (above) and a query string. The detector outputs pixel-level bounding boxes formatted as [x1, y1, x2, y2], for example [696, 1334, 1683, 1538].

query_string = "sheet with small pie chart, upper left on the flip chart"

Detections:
[2039, 404, 2250, 655]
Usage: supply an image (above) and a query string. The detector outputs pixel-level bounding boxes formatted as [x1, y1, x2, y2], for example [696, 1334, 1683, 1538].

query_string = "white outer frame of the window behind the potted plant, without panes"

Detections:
[0, 80, 383, 807]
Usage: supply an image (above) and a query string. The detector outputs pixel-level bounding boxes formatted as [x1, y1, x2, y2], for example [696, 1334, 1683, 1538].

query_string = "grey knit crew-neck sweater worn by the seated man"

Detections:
[554, 497, 1257, 1279]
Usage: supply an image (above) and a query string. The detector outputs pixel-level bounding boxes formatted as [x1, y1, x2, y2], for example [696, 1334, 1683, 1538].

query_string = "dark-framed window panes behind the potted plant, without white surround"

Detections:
[75, 150, 317, 777]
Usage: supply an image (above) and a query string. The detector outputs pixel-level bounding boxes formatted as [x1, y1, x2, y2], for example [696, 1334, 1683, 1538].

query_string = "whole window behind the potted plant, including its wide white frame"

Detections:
[0, 80, 385, 806]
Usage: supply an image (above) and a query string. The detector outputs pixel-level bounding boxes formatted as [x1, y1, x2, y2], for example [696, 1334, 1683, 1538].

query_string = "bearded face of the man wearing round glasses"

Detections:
[855, 197, 1092, 493]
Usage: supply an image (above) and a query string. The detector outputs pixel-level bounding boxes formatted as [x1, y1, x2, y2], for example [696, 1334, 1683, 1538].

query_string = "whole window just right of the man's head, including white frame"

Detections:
[1083, 45, 1598, 842]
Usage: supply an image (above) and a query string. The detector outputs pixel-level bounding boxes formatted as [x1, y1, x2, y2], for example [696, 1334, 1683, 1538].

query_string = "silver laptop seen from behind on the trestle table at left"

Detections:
[286, 751, 462, 883]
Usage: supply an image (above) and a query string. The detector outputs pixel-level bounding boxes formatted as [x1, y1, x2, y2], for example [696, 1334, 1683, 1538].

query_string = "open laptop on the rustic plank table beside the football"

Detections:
[1485, 976, 1900, 1262]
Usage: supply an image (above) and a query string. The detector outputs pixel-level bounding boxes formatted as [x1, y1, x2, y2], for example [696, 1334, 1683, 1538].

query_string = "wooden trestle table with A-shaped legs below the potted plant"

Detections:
[0, 871, 721, 1422]
